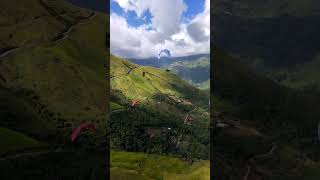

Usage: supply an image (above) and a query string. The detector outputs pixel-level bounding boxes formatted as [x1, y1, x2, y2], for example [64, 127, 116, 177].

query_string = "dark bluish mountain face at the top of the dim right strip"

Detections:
[214, 16, 320, 67]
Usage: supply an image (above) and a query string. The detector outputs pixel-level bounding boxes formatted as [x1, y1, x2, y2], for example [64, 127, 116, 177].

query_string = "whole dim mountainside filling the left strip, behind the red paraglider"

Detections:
[0, 0, 109, 179]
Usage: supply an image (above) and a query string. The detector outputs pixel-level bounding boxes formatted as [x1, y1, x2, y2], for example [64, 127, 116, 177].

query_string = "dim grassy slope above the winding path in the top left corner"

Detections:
[0, 0, 89, 48]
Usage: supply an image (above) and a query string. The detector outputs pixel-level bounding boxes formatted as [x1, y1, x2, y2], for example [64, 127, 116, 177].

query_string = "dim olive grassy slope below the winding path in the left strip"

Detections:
[0, 0, 108, 141]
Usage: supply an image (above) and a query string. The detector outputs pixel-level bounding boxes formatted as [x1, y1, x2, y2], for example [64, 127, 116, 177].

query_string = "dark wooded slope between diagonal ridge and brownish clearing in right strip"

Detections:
[213, 49, 318, 134]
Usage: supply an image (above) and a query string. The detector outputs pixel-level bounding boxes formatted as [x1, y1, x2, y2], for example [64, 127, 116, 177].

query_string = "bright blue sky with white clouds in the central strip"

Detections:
[110, 0, 210, 59]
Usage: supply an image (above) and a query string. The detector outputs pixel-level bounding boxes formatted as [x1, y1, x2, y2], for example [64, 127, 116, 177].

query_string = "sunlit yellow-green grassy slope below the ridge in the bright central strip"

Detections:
[110, 56, 208, 106]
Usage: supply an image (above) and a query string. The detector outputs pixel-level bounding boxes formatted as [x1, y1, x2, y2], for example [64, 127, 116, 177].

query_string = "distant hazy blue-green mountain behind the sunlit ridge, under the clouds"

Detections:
[130, 54, 210, 89]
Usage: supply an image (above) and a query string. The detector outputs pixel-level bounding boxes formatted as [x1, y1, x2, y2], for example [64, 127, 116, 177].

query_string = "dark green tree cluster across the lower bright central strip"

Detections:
[110, 100, 209, 160]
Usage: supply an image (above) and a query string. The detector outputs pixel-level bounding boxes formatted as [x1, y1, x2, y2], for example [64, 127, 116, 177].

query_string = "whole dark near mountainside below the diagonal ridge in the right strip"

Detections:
[211, 47, 320, 180]
